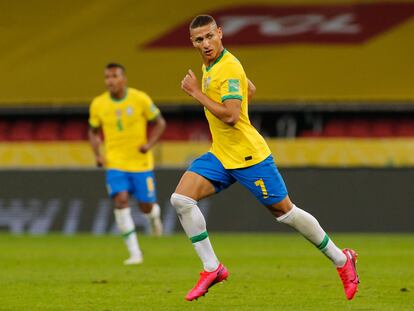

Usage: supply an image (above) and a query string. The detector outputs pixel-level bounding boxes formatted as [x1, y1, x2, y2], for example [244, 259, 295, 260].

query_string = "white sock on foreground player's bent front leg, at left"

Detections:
[171, 193, 219, 272]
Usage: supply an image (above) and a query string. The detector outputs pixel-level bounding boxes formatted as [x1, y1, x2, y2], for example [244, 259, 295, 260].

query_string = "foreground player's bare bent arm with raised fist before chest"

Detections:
[181, 70, 241, 126]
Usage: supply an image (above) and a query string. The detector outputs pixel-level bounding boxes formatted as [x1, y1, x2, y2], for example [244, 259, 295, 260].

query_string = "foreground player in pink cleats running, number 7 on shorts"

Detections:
[171, 15, 359, 301]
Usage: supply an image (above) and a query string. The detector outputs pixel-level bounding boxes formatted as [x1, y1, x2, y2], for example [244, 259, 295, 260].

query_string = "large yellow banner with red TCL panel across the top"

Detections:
[0, 0, 414, 107]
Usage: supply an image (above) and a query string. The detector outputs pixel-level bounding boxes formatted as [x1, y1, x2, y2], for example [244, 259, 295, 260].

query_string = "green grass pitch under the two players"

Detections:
[0, 233, 414, 311]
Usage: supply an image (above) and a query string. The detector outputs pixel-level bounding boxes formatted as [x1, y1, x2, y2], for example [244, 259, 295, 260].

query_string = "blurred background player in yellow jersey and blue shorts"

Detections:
[89, 63, 166, 265]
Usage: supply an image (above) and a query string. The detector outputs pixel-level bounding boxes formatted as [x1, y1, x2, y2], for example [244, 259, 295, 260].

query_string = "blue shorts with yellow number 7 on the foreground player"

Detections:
[188, 152, 288, 205]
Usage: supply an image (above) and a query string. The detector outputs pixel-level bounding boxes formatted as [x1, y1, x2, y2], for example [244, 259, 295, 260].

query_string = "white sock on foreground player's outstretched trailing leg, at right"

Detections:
[276, 205, 346, 267]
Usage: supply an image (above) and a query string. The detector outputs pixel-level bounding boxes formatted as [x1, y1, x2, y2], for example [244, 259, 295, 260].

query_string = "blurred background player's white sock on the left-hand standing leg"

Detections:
[114, 207, 142, 256]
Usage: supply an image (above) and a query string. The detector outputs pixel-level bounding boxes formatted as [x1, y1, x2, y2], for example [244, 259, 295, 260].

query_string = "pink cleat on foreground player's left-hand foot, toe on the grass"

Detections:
[185, 264, 229, 301]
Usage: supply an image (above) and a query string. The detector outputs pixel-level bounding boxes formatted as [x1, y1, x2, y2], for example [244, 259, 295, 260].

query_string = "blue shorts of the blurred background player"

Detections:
[106, 169, 157, 203]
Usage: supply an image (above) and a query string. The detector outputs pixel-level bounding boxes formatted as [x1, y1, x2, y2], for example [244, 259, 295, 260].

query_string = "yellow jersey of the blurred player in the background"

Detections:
[89, 88, 160, 172]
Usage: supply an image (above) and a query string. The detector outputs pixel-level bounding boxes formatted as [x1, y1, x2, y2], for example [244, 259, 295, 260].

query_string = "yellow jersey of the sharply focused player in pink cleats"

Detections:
[202, 49, 270, 169]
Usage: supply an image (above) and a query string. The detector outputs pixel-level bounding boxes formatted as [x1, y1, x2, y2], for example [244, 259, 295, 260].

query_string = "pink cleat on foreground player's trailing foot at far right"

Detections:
[336, 248, 359, 300]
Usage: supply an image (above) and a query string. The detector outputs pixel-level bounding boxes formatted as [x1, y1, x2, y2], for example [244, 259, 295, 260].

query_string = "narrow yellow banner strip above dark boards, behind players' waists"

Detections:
[0, 138, 414, 168]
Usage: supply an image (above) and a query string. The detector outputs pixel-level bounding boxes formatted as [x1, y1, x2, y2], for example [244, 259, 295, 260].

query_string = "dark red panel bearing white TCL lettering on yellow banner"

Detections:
[146, 2, 414, 48]
